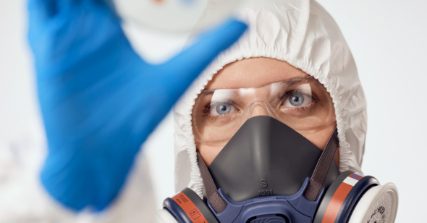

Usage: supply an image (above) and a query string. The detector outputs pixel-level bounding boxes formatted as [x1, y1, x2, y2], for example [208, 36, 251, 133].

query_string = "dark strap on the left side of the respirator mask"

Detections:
[197, 153, 227, 213]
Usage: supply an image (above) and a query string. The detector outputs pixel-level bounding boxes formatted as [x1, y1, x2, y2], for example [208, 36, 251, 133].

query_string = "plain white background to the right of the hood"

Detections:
[321, 0, 427, 222]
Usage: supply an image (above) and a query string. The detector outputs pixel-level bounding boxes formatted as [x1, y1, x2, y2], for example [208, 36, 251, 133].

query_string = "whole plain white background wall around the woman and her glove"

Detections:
[0, 0, 427, 222]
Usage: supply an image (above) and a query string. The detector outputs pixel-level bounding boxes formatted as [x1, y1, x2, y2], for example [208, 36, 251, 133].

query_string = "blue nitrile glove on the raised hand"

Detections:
[29, 0, 246, 210]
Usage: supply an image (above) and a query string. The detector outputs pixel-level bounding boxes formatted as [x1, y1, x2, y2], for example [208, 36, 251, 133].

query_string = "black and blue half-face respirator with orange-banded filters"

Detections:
[164, 116, 398, 223]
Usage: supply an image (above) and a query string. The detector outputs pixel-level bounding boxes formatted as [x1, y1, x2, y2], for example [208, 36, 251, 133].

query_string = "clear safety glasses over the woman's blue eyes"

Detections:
[192, 77, 335, 143]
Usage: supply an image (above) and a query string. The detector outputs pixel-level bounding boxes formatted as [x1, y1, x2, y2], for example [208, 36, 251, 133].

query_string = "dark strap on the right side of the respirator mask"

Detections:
[304, 129, 338, 201]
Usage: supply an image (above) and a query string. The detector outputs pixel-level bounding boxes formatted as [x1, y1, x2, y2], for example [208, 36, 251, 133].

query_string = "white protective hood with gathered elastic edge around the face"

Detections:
[174, 0, 367, 199]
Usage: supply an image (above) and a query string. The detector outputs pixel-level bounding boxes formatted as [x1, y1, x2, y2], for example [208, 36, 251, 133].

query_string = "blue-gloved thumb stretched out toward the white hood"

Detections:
[161, 18, 247, 96]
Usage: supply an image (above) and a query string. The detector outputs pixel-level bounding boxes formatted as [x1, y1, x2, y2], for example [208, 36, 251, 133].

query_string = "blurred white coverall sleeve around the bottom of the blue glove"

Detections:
[0, 136, 157, 223]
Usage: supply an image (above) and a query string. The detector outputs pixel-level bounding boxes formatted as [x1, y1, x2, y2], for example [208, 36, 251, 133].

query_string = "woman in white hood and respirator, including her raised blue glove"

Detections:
[25, 0, 397, 222]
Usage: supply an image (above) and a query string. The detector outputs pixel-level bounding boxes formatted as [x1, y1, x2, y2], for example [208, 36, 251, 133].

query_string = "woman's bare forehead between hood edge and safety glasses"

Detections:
[205, 57, 309, 90]
